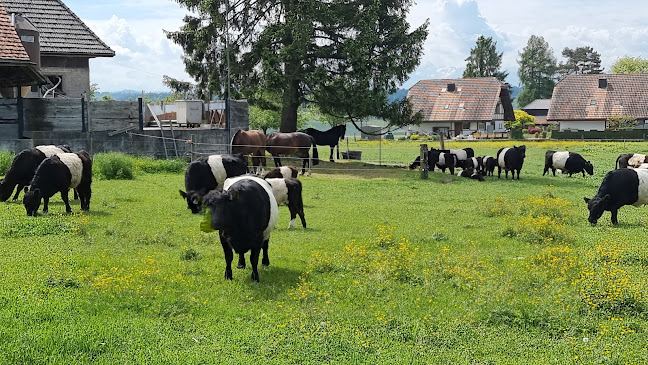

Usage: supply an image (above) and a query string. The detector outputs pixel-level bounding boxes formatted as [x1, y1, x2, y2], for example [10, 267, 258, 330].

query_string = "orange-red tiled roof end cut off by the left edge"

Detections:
[0, 4, 45, 98]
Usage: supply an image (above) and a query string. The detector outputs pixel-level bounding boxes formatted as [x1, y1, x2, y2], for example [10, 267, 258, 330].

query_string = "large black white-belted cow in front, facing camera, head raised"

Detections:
[203, 175, 279, 281]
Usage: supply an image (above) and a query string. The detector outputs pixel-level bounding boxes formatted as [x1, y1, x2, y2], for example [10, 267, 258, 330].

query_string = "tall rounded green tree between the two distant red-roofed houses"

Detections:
[517, 35, 557, 108]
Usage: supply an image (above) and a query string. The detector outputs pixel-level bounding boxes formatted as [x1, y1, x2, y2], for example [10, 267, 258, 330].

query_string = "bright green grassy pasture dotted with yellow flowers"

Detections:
[0, 141, 648, 364]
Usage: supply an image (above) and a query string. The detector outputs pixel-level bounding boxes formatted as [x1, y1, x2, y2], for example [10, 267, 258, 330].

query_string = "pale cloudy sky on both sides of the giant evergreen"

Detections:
[63, 0, 648, 91]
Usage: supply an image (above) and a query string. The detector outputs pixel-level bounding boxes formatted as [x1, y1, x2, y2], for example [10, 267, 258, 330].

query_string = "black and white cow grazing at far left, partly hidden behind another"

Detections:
[0, 145, 72, 201]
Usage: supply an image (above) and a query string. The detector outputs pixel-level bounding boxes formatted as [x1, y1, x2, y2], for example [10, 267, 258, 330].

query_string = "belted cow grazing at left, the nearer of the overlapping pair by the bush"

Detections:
[23, 151, 92, 216]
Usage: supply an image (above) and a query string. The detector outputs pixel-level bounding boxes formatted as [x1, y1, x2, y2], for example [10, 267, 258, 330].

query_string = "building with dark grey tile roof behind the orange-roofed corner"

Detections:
[0, 0, 115, 98]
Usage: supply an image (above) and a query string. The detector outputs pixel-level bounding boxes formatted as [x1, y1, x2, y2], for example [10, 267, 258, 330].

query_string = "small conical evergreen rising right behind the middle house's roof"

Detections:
[463, 35, 508, 81]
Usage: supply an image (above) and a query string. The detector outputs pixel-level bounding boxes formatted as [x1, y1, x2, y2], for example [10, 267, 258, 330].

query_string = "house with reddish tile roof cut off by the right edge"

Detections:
[547, 74, 648, 131]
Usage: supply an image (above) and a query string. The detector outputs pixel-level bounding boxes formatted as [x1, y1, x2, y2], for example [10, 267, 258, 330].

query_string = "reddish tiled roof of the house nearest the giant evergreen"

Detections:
[407, 77, 512, 122]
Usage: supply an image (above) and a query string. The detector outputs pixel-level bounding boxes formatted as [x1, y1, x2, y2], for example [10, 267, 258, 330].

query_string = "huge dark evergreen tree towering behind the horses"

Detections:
[167, 0, 428, 132]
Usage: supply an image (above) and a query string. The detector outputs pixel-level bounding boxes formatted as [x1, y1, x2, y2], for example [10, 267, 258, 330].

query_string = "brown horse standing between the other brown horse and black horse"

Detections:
[266, 132, 319, 175]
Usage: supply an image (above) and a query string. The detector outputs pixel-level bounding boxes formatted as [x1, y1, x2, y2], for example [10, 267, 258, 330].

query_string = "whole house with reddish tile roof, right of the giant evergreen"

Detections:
[407, 77, 515, 137]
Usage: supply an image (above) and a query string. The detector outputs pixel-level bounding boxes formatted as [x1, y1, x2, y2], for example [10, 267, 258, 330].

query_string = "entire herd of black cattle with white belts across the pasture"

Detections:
[0, 145, 648, 281]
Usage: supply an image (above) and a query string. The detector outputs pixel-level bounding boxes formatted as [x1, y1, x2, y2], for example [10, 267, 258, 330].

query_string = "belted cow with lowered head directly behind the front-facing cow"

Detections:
[180, 153, 248, 214]
